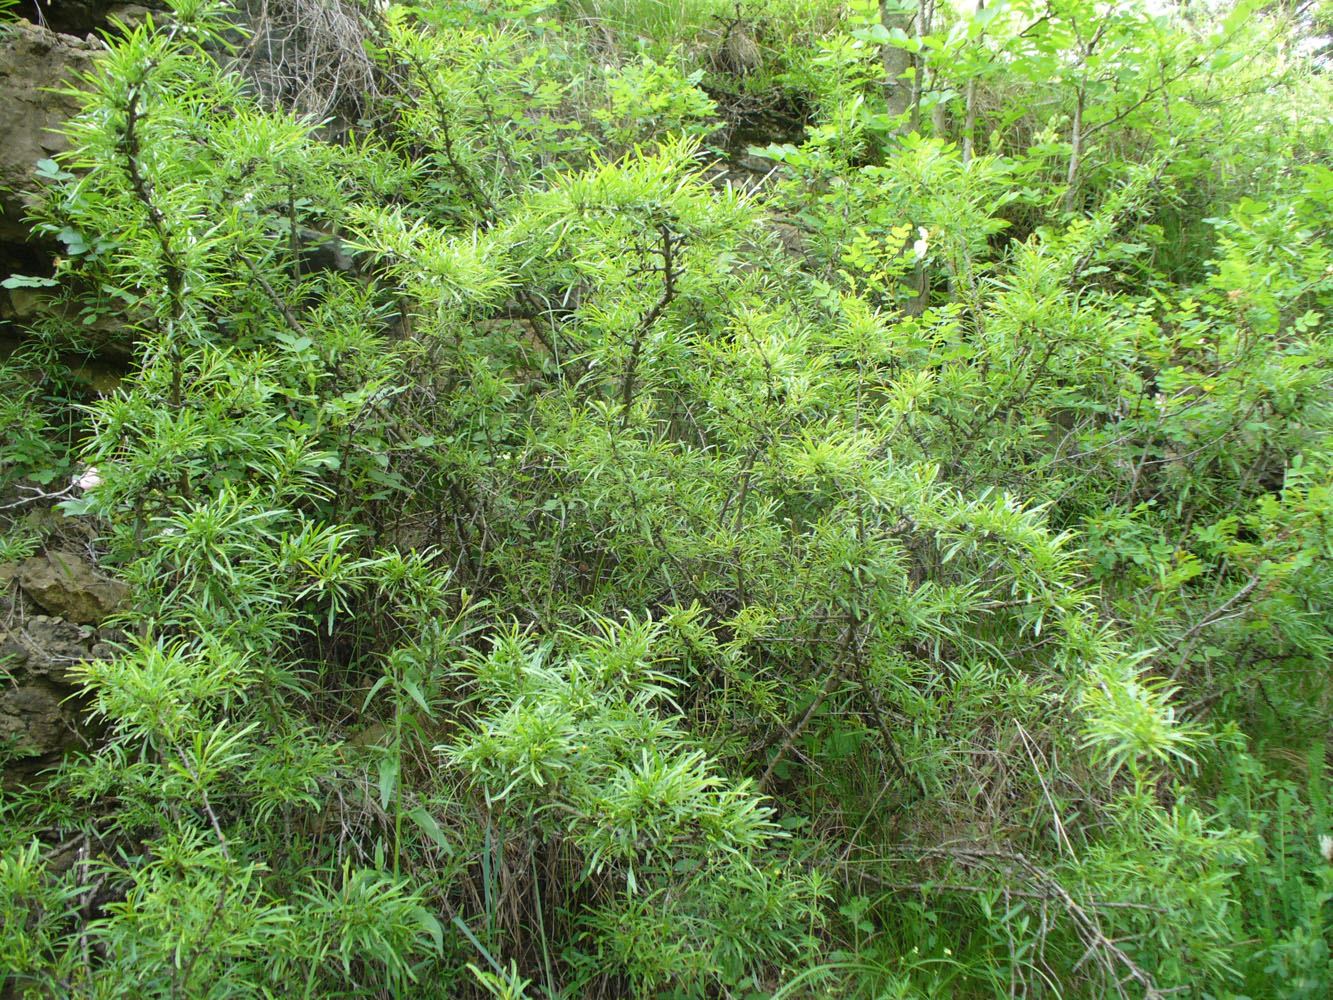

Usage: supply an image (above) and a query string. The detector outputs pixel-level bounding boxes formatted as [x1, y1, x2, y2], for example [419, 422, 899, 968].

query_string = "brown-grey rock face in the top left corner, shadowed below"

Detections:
[0, 21, 103, 282]
